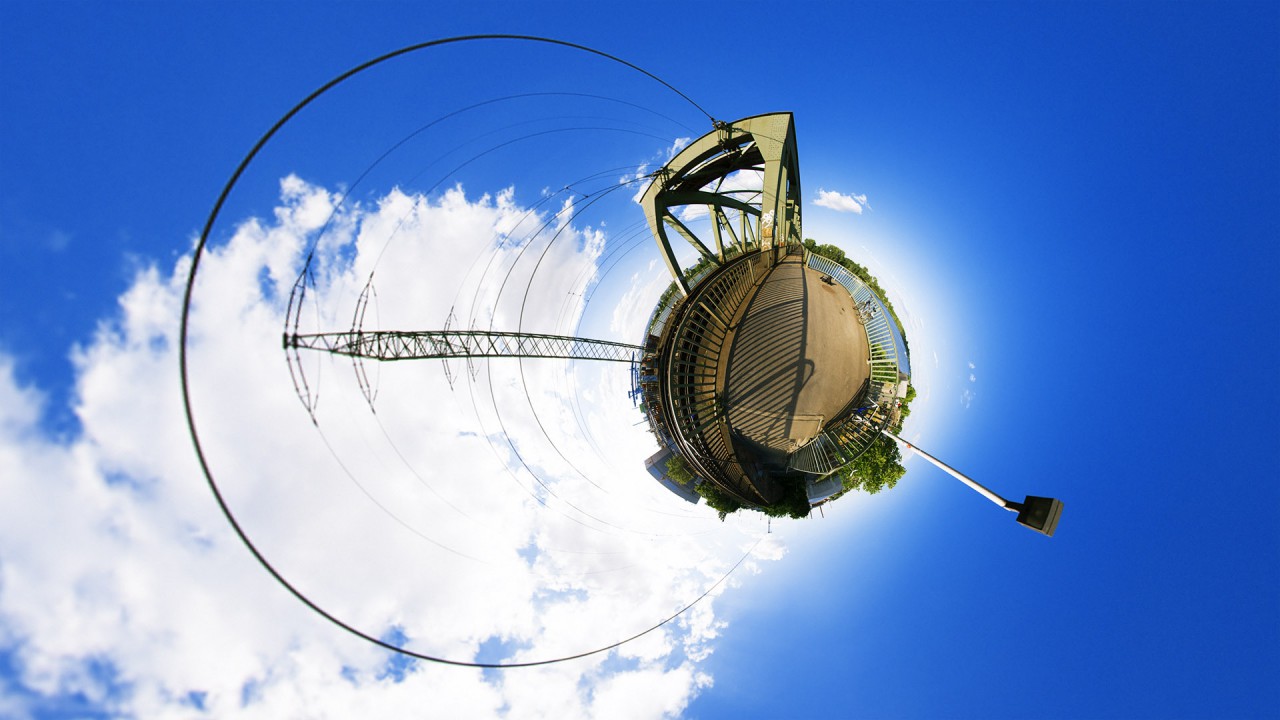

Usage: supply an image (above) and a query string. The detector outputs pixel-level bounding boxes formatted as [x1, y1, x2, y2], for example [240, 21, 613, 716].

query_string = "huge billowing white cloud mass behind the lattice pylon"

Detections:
[0, 178, 781, 717]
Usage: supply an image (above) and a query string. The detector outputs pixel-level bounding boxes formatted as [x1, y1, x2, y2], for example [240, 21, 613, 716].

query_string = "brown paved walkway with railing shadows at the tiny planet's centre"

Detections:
[723, 255, 869, 462]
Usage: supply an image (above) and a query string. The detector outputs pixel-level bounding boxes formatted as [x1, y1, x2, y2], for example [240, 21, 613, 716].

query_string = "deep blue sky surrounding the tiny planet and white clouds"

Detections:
[0, 3, 1280, 719]
